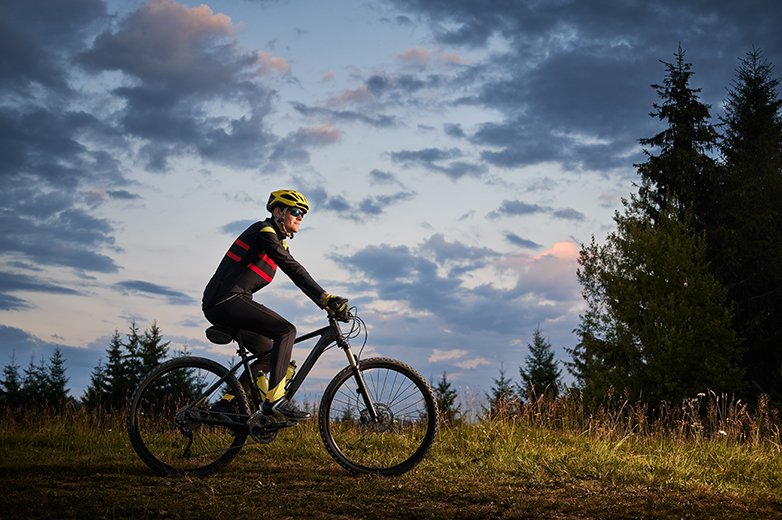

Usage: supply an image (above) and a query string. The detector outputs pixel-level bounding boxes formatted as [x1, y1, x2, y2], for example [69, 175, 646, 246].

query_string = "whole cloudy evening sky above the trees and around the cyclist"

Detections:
[0, 0, 782, 400]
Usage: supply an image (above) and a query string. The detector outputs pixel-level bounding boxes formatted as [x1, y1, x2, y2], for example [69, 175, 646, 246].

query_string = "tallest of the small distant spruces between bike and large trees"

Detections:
[519, 326, 562, 400]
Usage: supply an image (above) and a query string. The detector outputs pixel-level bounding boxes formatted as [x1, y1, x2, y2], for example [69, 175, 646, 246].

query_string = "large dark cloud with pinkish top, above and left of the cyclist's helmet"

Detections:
[77, 0, 280, 170]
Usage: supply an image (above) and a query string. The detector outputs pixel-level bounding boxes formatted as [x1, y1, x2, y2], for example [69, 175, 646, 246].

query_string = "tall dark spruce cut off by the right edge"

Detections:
[709, 49, 782, 400]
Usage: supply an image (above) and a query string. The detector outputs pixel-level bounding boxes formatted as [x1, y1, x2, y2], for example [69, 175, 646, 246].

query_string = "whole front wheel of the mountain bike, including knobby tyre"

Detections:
[318, 358, 437, 476]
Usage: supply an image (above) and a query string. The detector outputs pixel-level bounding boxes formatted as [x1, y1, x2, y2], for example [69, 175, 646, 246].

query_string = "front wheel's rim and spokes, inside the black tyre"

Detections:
[328, 366, 436, 473]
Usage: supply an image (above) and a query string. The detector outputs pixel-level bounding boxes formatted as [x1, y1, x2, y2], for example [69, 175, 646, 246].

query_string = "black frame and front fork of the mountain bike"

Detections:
[196, 314, 378, 422]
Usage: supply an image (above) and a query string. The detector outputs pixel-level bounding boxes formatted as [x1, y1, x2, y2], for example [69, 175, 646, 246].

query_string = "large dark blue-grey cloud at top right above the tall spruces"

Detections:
[393, 0, 782, 175]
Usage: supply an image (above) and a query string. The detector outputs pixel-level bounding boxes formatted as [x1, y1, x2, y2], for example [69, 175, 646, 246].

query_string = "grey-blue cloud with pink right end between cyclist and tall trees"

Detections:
[337, 235, 580, 341]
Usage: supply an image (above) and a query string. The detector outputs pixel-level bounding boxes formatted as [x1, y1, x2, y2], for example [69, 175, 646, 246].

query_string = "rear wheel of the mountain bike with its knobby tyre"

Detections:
[128, 356, 249, 476]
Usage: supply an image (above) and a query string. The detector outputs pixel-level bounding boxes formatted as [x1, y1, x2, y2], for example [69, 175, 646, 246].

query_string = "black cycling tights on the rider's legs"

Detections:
[204, 295, 296, 396]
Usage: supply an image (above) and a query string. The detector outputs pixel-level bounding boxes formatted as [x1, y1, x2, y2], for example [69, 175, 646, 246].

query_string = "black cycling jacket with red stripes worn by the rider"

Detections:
[201, 218, 324, 309]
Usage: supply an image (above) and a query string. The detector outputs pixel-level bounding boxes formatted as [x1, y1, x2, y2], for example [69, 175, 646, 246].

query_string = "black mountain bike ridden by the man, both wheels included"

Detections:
[128, 308, 438, 476]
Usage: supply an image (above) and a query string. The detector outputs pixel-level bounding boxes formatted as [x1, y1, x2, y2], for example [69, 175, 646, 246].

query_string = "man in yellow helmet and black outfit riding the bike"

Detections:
[202, 190, 348, 420]
